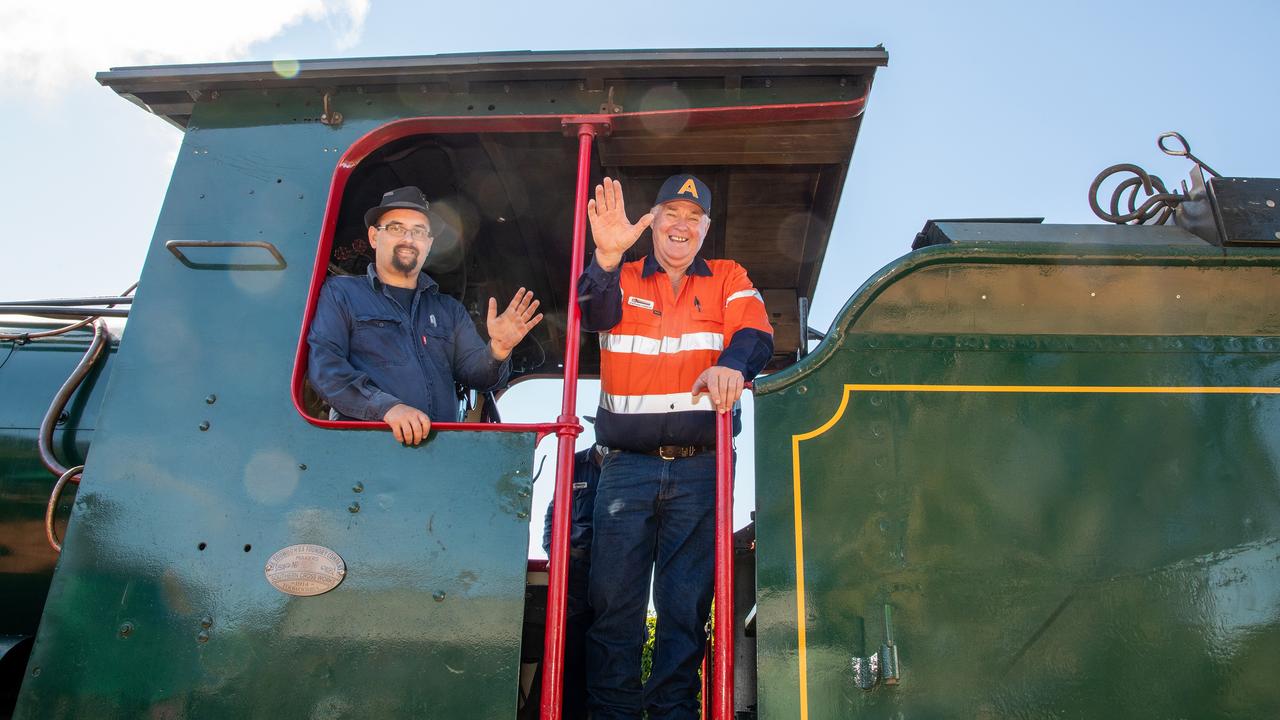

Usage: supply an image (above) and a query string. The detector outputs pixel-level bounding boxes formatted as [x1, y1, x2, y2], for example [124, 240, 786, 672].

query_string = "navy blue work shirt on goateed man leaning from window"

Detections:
[307, 264, 511, 421]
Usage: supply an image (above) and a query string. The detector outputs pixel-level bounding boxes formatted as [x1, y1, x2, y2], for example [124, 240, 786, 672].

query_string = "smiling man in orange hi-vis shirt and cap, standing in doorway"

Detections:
[579, 174, 773, 720]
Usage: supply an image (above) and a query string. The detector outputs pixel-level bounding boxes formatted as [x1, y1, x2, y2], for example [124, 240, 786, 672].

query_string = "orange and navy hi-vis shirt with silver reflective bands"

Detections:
[579, 255, 773, 451]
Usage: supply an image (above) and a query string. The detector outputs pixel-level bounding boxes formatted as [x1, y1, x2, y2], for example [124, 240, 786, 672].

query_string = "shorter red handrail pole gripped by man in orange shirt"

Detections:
[712, 413, 735, 720]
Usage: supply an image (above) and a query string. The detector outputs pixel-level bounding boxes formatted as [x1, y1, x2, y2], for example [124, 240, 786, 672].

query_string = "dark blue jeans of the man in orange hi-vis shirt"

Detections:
[586, 451, 716, 720]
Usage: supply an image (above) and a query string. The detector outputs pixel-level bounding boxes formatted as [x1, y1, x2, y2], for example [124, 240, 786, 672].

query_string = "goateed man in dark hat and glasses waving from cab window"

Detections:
[307, 187, 543, 445]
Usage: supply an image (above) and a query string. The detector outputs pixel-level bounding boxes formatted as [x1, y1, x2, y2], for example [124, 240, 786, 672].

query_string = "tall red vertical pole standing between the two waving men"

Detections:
[541, 124, 595, 720]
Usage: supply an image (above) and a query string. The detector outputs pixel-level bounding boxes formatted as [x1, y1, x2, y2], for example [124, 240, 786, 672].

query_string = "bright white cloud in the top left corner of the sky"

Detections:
[0, 0, 370, 99]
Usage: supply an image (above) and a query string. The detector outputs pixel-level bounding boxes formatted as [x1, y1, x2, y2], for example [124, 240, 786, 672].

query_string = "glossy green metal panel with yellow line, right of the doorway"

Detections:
[755, 247, 1280, 719]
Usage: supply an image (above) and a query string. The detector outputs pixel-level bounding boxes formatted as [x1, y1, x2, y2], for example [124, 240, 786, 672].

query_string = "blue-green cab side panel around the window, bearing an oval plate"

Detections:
[17, 94, 535, 719]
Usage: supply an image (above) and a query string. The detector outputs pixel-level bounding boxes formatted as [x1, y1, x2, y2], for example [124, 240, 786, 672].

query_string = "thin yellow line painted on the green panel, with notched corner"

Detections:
[791, 384, 1280, 720]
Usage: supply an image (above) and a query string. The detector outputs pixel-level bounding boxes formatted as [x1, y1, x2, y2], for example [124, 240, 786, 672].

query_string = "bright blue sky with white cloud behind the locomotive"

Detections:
[0, 0, 1280, 548]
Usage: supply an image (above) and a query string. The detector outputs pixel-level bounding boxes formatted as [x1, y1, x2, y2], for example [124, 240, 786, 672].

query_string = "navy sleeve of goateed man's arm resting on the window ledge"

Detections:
[307, 278, 401, 421]
